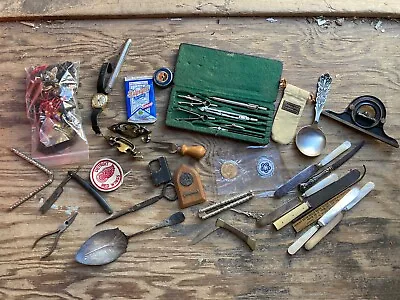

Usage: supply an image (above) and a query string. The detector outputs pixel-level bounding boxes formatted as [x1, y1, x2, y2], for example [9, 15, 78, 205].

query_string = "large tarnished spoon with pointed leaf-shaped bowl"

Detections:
[75, 212, 185, 266]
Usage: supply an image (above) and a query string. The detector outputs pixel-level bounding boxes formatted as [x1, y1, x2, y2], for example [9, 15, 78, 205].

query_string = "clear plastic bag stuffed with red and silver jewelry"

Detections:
[25, 61, 89, 166]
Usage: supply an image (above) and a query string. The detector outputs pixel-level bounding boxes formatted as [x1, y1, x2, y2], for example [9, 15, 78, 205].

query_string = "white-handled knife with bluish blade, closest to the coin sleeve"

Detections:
[274, 141, 351, 198]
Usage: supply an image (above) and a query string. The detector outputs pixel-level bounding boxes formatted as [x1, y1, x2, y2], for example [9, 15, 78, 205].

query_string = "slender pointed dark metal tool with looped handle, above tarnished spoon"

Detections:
[96, 182, 178, 226]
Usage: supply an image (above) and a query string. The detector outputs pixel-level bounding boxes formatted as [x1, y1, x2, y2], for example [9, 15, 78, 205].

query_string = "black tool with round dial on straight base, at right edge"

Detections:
[322, 95, 399, 148]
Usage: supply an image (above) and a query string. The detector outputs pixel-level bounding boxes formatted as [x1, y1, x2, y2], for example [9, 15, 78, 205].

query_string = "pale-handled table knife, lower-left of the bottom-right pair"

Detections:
[288, 188, 360, 255]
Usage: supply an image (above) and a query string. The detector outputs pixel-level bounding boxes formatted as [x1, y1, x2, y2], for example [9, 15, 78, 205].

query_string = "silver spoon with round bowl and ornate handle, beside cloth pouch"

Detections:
[296, 74, 332, 157]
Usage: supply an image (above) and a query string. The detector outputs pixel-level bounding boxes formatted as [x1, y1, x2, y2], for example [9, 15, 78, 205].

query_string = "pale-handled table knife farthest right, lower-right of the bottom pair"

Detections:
[304, 182, 375, 250]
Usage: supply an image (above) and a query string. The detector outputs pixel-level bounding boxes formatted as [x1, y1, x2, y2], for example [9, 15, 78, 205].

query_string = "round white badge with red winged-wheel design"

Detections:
[89, 158, 124, 192]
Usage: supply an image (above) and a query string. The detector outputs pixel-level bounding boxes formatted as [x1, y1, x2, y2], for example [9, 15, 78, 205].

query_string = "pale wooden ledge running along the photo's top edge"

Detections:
[0, 0, 400, 20]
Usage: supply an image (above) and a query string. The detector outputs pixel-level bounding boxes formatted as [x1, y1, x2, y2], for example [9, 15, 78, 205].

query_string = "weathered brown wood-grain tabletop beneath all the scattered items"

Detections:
[0, 18, 400, 300]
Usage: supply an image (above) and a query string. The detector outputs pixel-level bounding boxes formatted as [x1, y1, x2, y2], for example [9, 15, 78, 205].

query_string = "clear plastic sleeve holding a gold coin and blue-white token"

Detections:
[214, 143, 288, 197]
